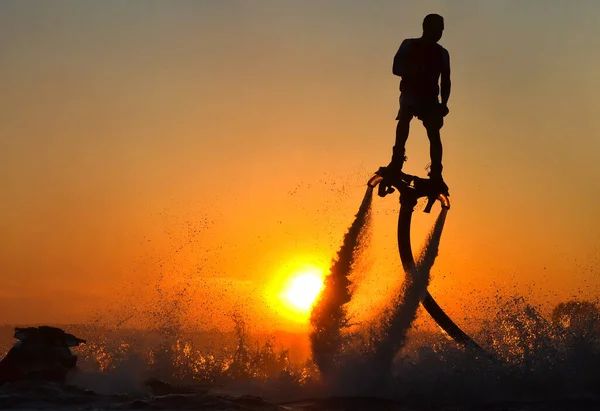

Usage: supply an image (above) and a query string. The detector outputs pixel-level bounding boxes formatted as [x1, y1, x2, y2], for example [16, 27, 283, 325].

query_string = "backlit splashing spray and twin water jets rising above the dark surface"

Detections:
[0, 185, 600, 410]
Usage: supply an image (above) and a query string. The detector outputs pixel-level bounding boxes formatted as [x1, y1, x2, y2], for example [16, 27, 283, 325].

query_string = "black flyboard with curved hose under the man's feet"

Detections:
[368, 167, 485, 353]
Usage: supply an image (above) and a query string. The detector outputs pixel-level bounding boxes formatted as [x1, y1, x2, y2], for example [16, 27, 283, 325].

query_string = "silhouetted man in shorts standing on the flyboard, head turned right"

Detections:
[388, 14, 450, 183]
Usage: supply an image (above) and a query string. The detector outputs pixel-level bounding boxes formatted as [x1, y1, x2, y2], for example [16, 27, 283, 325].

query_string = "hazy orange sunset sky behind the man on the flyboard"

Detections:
[0, 0, 600, 326]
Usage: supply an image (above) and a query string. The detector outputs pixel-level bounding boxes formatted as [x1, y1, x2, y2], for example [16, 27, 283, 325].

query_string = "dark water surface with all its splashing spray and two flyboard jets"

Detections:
[0, 188, 600, 410]
